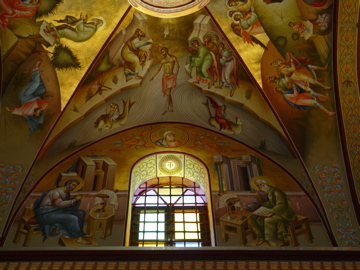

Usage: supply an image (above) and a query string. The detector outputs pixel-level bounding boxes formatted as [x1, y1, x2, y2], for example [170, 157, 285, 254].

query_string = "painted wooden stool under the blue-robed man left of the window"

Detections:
[14, 207, 41, 247]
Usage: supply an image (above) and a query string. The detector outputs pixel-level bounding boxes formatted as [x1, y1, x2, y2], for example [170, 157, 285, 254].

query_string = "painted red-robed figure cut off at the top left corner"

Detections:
[0, 0, 42, 32]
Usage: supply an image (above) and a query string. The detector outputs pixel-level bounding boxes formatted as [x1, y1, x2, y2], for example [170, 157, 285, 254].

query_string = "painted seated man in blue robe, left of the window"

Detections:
[34, 177, 91, 245]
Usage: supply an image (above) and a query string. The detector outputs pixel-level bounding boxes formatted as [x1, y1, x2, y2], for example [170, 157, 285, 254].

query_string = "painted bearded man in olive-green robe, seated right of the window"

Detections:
[248, 178, 296, 247]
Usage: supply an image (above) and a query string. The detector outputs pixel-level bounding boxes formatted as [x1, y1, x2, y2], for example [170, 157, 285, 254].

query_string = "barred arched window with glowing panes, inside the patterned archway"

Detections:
[129, 177, 211, 247]
